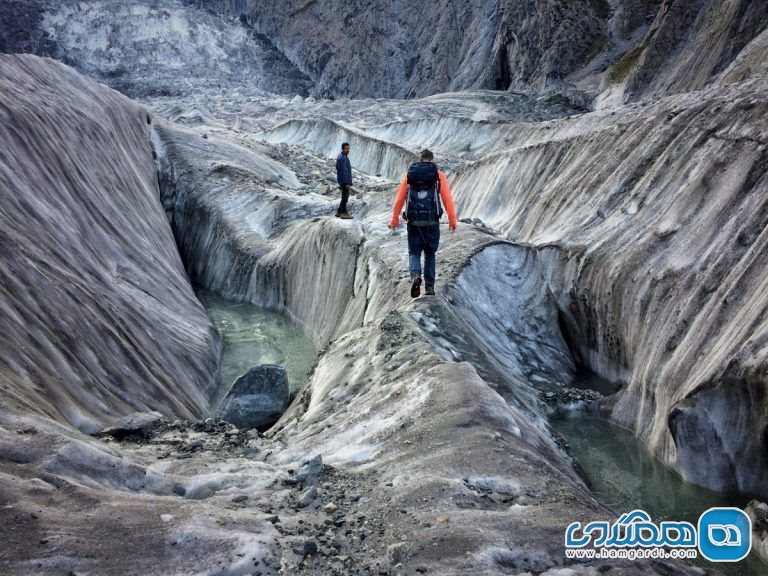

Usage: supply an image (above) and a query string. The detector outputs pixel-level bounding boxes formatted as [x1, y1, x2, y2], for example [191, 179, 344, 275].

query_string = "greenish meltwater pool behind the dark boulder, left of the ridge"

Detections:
[200, 289, 317, 403]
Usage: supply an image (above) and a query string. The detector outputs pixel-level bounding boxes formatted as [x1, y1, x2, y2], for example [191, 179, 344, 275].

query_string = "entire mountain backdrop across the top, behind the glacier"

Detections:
[0, 0, 768, 107]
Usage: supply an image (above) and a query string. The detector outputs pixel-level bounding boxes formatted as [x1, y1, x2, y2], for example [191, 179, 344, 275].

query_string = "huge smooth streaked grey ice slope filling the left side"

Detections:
[0, 55, 220, 432]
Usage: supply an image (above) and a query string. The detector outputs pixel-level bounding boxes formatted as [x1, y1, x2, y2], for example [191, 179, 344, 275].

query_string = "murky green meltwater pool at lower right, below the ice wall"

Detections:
[550, 415, 768, 576]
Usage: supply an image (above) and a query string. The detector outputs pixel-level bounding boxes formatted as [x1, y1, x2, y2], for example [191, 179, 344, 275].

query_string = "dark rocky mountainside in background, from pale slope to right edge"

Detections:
[184, 0, 768, 103]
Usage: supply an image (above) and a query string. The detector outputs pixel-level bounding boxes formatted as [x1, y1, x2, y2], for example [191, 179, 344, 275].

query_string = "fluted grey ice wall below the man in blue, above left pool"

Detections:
[157, 125, 378, 348]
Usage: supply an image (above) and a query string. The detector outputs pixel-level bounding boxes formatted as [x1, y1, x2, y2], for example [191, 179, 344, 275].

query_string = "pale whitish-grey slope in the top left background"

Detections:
[0, 0, 312, 97]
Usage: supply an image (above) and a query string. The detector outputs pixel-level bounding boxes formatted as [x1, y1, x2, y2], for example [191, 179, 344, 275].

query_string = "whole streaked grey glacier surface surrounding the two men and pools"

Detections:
[0, 7, 768, 574]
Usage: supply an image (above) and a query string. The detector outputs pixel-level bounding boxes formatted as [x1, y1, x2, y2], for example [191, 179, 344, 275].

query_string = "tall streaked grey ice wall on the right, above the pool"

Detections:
[453, 80, 768, 493]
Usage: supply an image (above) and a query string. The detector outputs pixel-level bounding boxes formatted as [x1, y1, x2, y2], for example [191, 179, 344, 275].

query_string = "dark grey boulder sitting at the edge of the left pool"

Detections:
[216, 364, 289, 428]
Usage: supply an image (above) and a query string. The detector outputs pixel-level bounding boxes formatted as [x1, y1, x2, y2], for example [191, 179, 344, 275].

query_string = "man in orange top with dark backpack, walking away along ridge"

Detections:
[389, 149, 458, 298]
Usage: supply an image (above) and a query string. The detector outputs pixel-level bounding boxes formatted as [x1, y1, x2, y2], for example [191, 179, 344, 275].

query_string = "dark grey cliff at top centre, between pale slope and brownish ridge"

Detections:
[189, 0, 610, 98]
